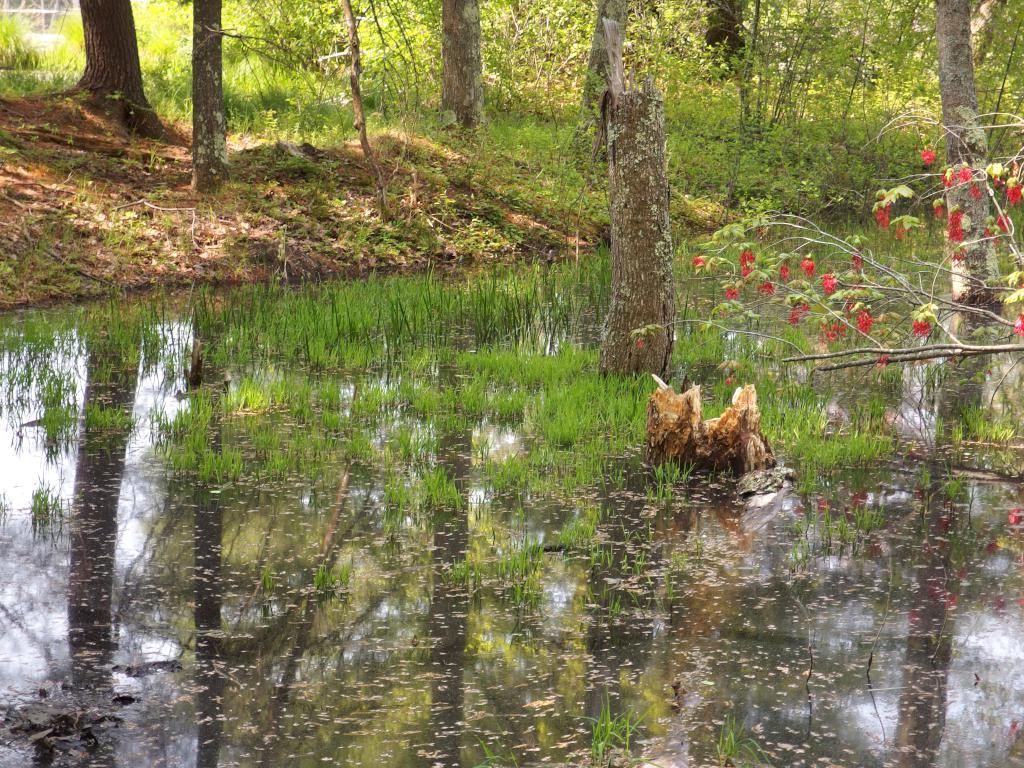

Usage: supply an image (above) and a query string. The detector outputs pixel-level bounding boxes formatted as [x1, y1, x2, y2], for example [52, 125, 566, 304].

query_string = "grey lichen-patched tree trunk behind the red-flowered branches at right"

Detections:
[935, 0, 997, 305]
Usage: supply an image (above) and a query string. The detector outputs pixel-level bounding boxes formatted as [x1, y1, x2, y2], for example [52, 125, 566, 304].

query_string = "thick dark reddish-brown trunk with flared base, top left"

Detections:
[78, 0, 164, 138]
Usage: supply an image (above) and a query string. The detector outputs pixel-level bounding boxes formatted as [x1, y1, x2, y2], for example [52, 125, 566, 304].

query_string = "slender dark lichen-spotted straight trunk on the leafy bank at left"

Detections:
[193, 0, 227, 193]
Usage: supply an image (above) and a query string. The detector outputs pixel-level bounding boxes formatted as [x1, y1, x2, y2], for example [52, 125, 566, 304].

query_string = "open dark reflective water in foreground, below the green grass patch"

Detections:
[0, 309, 1024, 768]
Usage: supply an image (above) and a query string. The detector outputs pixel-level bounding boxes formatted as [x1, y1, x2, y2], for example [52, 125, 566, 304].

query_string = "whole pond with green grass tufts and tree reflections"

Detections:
[0, 262, 1024, 768]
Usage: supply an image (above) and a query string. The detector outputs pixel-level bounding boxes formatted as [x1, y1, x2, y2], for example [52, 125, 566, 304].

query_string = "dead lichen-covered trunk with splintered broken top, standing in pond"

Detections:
[601, 22, 676, 376]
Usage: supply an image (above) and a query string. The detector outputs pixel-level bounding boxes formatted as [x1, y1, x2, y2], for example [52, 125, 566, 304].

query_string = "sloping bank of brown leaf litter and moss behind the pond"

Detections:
[0, 96, 737, 307]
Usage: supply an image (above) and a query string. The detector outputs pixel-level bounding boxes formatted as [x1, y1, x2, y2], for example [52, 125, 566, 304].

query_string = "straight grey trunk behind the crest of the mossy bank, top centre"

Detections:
[441, 0, 483, 128]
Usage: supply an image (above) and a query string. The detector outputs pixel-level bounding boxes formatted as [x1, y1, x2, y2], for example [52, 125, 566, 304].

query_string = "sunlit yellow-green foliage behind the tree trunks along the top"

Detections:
[6, 0, 1024, 216]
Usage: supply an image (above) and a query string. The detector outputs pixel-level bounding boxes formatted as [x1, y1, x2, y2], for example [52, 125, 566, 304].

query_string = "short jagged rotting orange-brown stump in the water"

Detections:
[647, 384, 775, 475]
